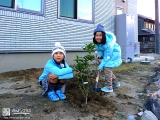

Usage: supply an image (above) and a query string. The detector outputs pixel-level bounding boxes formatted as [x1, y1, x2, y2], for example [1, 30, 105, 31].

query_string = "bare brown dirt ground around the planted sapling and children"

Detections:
[0, 54, 160, 120]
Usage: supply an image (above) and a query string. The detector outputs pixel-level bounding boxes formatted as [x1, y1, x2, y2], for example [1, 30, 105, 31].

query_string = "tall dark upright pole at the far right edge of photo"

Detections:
[155, 0, 160, 54]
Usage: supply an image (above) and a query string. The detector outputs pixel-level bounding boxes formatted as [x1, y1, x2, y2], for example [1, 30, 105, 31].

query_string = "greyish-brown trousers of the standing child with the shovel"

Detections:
[104, 68, 118, 88]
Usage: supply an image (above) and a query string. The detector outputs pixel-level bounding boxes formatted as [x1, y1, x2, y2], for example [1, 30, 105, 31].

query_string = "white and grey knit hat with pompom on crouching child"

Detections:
[52, 42, 66, 57]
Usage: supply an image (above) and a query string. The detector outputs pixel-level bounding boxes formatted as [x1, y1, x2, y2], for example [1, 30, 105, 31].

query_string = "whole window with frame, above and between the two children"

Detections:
[58, 0, 94, 22]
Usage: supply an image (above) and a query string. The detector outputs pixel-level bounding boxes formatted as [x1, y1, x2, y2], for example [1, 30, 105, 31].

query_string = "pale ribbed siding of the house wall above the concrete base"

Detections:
[0, 0, 115, 53]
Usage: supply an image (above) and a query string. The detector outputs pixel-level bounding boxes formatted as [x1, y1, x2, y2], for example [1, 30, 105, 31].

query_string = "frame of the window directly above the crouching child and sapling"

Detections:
[57, 0, 95, 24]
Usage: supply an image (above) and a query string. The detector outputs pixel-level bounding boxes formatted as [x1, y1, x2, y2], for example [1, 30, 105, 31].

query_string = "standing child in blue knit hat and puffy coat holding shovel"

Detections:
[93, 24, 122, 92]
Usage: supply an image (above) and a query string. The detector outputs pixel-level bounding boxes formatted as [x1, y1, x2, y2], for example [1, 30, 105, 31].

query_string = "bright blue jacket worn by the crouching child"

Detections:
[38, 59, 73, 82]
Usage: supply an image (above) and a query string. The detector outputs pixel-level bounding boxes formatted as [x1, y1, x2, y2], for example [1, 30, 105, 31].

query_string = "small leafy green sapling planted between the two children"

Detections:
[74, 43, 95, 105]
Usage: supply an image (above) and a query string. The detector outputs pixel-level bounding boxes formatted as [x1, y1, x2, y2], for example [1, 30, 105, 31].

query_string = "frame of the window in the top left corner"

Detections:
[0, 0, 46, 16]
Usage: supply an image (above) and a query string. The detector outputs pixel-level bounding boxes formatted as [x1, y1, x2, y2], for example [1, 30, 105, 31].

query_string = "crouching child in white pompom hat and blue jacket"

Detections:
[38, 42, 73, 101]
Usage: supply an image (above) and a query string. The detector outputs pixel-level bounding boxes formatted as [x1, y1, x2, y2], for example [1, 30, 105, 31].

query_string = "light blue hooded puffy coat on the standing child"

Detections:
[96, 30, 122, 70]
